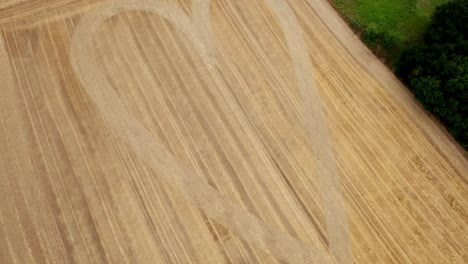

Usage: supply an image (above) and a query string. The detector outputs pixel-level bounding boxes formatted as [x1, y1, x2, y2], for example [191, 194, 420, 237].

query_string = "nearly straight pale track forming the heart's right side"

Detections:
[266, 0, 353, 263]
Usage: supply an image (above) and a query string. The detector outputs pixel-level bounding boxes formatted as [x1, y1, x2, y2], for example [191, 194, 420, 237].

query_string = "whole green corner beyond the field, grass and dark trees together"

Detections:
[330, 0, 468, 149]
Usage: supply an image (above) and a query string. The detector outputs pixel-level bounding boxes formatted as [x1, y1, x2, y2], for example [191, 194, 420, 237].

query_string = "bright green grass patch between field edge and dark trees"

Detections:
[333, 0, 448, 65]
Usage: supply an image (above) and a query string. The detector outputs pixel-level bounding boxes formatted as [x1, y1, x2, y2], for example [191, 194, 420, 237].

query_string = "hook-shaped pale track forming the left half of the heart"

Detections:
[70, 0, 331, 263]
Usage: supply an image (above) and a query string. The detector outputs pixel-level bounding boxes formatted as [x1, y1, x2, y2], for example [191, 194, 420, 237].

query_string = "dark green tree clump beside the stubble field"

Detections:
[395, 0, 468, 148]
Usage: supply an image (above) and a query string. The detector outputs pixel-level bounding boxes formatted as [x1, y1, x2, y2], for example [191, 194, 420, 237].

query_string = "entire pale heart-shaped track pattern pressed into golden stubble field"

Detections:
[71, 0, 352, 263]
